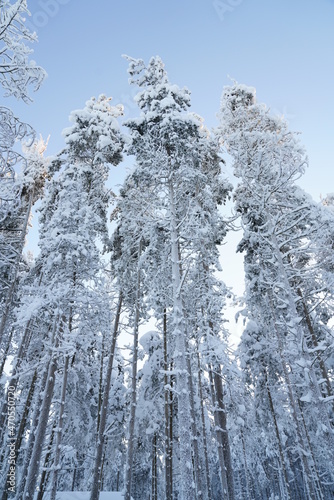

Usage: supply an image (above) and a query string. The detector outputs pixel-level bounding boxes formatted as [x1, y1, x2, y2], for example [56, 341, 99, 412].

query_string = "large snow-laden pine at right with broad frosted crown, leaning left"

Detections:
[221, 85, 333, 498]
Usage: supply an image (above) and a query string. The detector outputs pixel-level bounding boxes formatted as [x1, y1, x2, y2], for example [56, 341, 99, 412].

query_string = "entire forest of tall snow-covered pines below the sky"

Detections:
[0, 0, 334, 500]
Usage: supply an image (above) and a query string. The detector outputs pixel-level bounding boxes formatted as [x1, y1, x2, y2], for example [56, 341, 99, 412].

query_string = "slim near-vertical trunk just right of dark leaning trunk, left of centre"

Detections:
[124, 240, 142, 500]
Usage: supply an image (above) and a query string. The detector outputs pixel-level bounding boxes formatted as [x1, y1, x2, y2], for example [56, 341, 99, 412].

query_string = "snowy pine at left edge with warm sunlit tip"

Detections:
[0, 138, 48, 500]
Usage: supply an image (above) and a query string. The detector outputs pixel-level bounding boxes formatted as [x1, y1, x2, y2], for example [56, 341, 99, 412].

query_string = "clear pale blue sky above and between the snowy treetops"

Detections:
[2, 0, 334, 344]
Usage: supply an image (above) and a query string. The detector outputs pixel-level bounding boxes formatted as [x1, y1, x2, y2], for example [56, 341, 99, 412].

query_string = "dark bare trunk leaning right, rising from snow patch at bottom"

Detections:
[90, 292, 122, 500]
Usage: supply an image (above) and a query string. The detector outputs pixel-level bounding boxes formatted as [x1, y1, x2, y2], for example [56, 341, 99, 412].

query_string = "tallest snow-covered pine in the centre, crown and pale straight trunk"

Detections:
[119, 57, 232, 499]
